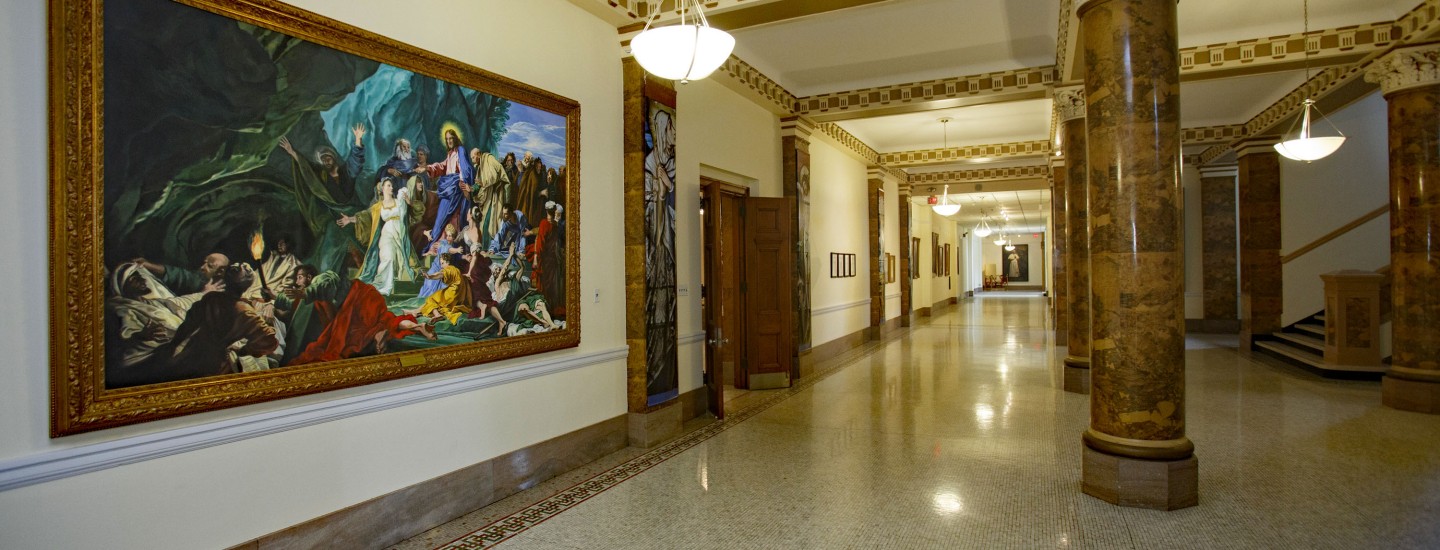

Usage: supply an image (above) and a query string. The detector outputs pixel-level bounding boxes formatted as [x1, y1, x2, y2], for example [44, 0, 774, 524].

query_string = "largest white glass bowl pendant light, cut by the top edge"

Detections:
[631, 0, 734, 84]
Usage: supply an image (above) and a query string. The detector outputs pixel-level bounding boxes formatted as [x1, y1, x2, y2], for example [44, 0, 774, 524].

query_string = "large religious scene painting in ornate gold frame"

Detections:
[49, 0, 580, 436]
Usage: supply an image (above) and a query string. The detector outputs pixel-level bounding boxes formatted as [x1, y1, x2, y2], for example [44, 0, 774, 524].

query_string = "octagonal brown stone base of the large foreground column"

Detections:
[1080, 443, 1200, 511]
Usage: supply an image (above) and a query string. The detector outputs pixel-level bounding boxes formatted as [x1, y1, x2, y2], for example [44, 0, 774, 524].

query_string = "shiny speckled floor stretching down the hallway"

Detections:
[397, 298, 1440, 549]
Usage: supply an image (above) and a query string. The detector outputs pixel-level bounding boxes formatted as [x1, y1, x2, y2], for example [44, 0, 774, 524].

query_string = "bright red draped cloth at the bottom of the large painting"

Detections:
[288, 281, 415, 366]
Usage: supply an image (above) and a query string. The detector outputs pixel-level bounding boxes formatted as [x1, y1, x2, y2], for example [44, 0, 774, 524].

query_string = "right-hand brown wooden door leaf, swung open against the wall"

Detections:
[740, 197, 795, 390]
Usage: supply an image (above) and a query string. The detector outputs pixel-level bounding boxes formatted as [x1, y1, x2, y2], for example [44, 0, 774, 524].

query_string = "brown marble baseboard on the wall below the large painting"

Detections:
[232, 415, 626, 550]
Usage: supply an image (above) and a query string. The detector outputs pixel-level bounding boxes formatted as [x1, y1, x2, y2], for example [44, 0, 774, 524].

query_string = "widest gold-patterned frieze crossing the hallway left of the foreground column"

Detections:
[795, 66, 1054, 121]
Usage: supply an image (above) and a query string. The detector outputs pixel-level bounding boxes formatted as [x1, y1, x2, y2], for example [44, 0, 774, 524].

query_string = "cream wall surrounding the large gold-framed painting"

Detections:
[0, 0, 630, 549]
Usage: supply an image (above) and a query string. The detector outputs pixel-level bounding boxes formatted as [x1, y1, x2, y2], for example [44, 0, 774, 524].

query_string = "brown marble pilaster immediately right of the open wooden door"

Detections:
[780, 117, 815, 380]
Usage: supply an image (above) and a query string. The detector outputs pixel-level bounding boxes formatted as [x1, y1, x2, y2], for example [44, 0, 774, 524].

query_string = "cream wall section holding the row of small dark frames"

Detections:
[809, 134, 870, 347]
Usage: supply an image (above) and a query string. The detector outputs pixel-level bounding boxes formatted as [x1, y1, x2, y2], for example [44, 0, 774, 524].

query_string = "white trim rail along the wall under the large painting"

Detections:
[0, 345, 630, 492]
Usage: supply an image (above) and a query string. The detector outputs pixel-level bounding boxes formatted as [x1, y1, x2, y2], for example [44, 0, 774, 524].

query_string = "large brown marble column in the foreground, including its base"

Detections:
[1079, 0, 1200, 510]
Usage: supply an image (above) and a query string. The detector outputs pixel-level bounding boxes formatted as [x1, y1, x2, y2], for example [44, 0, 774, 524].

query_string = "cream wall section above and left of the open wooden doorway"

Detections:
[675, 79, 782, 393]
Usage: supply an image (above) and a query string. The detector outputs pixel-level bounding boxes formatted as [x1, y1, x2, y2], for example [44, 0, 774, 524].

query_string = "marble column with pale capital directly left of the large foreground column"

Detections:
[1056, 86, 1090, 393]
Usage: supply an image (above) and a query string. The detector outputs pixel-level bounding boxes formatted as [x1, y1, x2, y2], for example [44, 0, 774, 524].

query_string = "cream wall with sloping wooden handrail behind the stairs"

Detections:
[1280, 91, 1390, 325]
